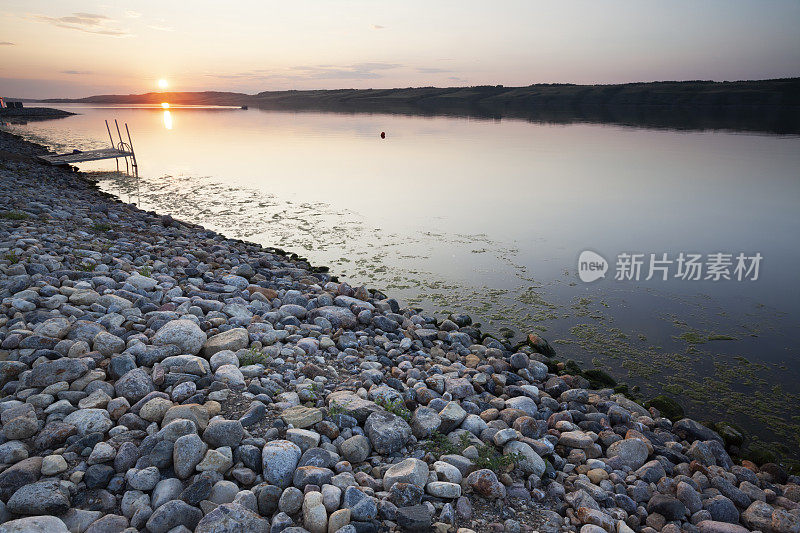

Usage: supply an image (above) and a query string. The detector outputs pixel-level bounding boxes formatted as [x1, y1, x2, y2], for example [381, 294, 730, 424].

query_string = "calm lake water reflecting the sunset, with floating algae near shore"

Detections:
[5, 105, 800, 458]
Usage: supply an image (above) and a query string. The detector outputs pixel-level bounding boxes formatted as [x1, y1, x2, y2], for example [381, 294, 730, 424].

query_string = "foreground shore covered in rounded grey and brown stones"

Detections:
[0, 132, 800, 533]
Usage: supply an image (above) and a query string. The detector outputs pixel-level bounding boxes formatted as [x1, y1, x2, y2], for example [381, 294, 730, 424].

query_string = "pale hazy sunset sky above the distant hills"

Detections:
[0, 0, 800, 98]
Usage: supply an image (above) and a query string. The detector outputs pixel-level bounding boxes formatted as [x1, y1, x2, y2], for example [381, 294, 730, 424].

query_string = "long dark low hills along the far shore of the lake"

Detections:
[34, 78, 800, 133]
